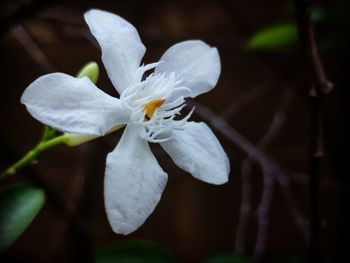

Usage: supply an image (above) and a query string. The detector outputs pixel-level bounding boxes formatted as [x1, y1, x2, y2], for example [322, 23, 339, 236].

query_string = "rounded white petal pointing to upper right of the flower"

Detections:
[155, 40, 221, 97]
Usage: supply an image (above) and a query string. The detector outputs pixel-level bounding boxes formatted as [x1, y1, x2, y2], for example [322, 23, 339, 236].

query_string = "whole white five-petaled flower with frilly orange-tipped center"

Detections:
[21, 10, 230, 234]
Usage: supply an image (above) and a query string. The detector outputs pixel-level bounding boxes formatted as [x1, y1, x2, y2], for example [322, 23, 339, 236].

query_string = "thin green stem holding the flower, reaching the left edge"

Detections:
[0, 134, 67, 180]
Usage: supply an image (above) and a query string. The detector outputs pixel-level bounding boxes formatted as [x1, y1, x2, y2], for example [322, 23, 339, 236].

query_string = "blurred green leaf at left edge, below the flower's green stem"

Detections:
[0, 185, 45, 253]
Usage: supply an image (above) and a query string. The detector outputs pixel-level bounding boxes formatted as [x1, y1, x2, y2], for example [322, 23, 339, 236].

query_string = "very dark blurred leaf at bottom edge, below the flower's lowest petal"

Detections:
[95, 240, 174, 263]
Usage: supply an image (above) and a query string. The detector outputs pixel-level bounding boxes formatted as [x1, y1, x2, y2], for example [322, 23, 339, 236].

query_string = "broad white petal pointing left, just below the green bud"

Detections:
[21, 73, 127, 135]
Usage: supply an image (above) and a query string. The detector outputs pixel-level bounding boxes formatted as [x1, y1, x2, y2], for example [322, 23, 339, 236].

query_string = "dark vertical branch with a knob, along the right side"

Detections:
[295, 0, 333, 262]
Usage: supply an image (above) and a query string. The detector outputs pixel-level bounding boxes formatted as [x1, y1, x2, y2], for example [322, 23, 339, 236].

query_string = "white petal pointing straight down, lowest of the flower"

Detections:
[104, 125, 167, 235]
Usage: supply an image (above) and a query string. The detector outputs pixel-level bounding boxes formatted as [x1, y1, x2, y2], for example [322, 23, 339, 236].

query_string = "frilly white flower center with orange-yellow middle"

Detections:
[120, 63, 193, 143]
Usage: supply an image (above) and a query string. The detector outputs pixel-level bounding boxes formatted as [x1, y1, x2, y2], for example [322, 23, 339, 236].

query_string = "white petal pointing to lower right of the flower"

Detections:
[161, 122, 230, 184]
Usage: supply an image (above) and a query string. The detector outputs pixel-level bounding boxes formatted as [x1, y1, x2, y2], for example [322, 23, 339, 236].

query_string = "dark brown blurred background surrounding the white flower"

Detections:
[0, 0, 350, 262]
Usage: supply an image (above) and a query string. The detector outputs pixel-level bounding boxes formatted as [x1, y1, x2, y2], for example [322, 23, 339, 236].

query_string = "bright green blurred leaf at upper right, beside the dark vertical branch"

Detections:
[247, 23, 298, 51]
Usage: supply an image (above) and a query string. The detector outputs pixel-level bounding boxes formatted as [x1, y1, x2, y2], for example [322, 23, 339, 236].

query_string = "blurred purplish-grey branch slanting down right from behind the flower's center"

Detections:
[188, 100, 308, 245]
